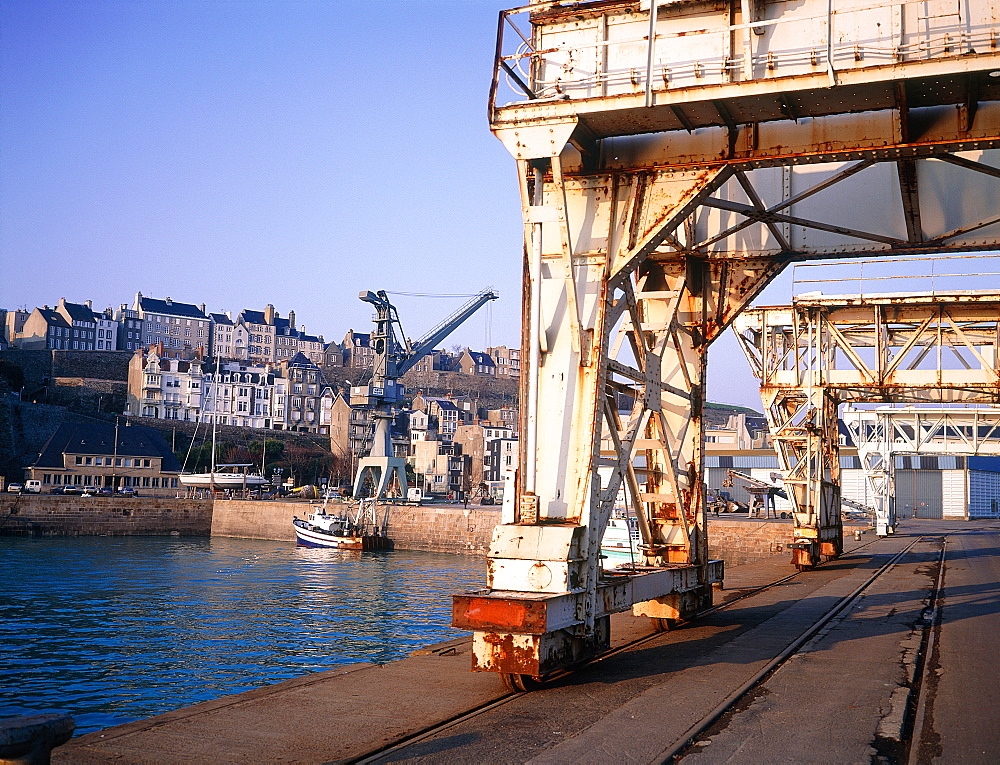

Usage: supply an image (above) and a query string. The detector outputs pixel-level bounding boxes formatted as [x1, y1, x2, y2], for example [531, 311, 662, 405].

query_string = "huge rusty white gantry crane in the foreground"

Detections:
[454, 0, 1000, 687]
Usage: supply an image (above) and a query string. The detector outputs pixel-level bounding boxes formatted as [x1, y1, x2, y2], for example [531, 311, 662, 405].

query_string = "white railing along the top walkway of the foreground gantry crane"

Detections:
[490, 0, 1000, 109]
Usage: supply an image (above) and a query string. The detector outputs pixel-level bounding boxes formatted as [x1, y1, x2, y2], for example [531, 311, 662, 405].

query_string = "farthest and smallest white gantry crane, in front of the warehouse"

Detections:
[844, 406, 1000, 536]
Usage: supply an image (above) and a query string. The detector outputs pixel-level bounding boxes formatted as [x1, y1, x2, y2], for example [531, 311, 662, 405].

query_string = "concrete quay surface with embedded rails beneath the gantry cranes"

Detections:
[53, 521, 1000, 763]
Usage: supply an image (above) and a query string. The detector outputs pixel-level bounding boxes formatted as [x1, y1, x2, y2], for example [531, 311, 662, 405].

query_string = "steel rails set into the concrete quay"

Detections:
[350, 537, 946, 764]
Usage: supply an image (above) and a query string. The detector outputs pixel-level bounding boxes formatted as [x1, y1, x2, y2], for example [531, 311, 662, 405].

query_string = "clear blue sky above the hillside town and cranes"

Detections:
[0, 0, 996, 408]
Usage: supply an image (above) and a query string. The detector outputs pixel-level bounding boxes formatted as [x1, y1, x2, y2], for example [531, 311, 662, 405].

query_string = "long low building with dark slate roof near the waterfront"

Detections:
[27, 422, 181, 497]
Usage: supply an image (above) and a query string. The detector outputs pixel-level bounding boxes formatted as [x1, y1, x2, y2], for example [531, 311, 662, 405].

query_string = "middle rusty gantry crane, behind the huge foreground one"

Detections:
[736, 292, 1000, 548]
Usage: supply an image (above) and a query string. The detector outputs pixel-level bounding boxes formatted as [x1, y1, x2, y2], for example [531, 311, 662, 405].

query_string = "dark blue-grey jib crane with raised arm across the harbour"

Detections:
[351, 288, 499, 499]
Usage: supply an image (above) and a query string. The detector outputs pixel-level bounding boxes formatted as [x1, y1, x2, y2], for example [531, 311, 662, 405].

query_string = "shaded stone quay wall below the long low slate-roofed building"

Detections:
[0, 495, 212, 536]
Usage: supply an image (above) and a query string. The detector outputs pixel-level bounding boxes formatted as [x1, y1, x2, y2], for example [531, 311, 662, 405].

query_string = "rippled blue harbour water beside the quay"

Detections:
[0, 537, 485, 734]
